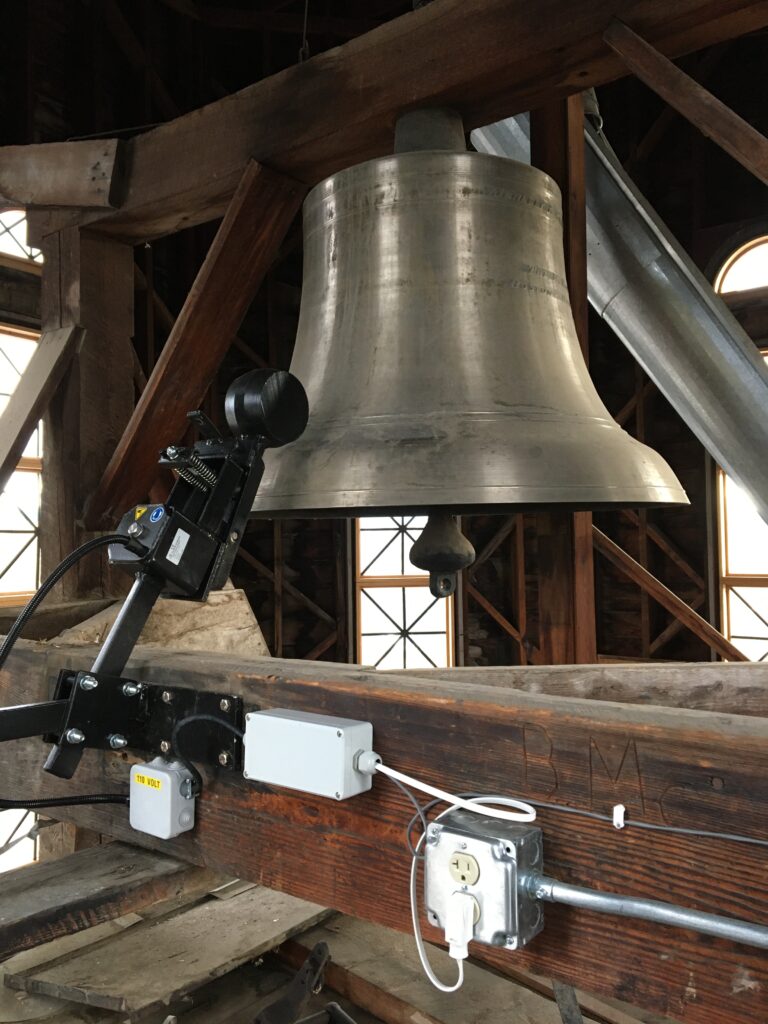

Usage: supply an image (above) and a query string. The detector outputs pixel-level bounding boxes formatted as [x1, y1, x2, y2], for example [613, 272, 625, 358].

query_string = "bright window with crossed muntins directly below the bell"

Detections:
[356, 516, 453, 669]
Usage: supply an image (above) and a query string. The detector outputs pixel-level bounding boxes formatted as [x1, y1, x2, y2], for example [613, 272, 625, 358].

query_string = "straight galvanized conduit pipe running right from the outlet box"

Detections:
[521, 873, 768, 949]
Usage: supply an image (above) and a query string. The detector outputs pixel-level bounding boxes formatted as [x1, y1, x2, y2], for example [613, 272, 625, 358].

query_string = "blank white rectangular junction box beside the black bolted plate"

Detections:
[243, 708, 374, 800]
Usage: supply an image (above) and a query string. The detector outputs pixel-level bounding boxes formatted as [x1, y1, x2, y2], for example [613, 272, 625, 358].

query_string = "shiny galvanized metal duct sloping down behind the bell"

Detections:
[471, 115, 768, 522]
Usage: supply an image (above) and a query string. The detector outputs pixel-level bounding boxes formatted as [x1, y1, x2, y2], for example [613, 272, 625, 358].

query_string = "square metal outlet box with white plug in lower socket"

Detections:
[424, 810, 544, 949]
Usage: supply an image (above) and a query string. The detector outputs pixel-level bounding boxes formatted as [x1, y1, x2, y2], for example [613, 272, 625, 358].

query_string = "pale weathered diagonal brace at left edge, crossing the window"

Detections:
[0, 326, 84, 490]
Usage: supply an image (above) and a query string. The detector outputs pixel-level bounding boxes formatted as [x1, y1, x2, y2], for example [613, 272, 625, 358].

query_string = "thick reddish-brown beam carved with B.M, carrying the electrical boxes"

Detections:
[0, 643, 768, 1024]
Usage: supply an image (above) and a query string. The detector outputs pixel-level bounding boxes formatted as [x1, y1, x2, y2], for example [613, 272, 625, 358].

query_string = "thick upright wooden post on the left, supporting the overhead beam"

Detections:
[40, 228, 134, 600]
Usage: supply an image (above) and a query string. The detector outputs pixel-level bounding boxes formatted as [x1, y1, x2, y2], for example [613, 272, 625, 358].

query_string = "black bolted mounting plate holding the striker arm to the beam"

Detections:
[46, 672, 243, 771]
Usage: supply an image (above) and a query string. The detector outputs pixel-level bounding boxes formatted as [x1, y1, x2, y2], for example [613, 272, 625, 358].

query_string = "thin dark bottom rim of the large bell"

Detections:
[251, 493, 690, 519]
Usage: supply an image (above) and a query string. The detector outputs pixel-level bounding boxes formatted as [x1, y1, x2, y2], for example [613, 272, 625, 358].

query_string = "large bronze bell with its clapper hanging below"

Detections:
[254, 111, 688, 596]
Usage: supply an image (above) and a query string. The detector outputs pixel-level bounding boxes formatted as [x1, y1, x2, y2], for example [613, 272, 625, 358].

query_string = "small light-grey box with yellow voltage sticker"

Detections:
[130, 758, 196, 839]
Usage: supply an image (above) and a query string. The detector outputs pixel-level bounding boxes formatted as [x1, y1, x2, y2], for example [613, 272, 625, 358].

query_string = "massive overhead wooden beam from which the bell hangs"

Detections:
[22, 0, 768, 240]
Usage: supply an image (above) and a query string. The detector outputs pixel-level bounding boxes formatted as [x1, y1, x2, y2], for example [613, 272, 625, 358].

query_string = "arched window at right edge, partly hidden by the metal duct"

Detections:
[715, 236, 768, 662]
